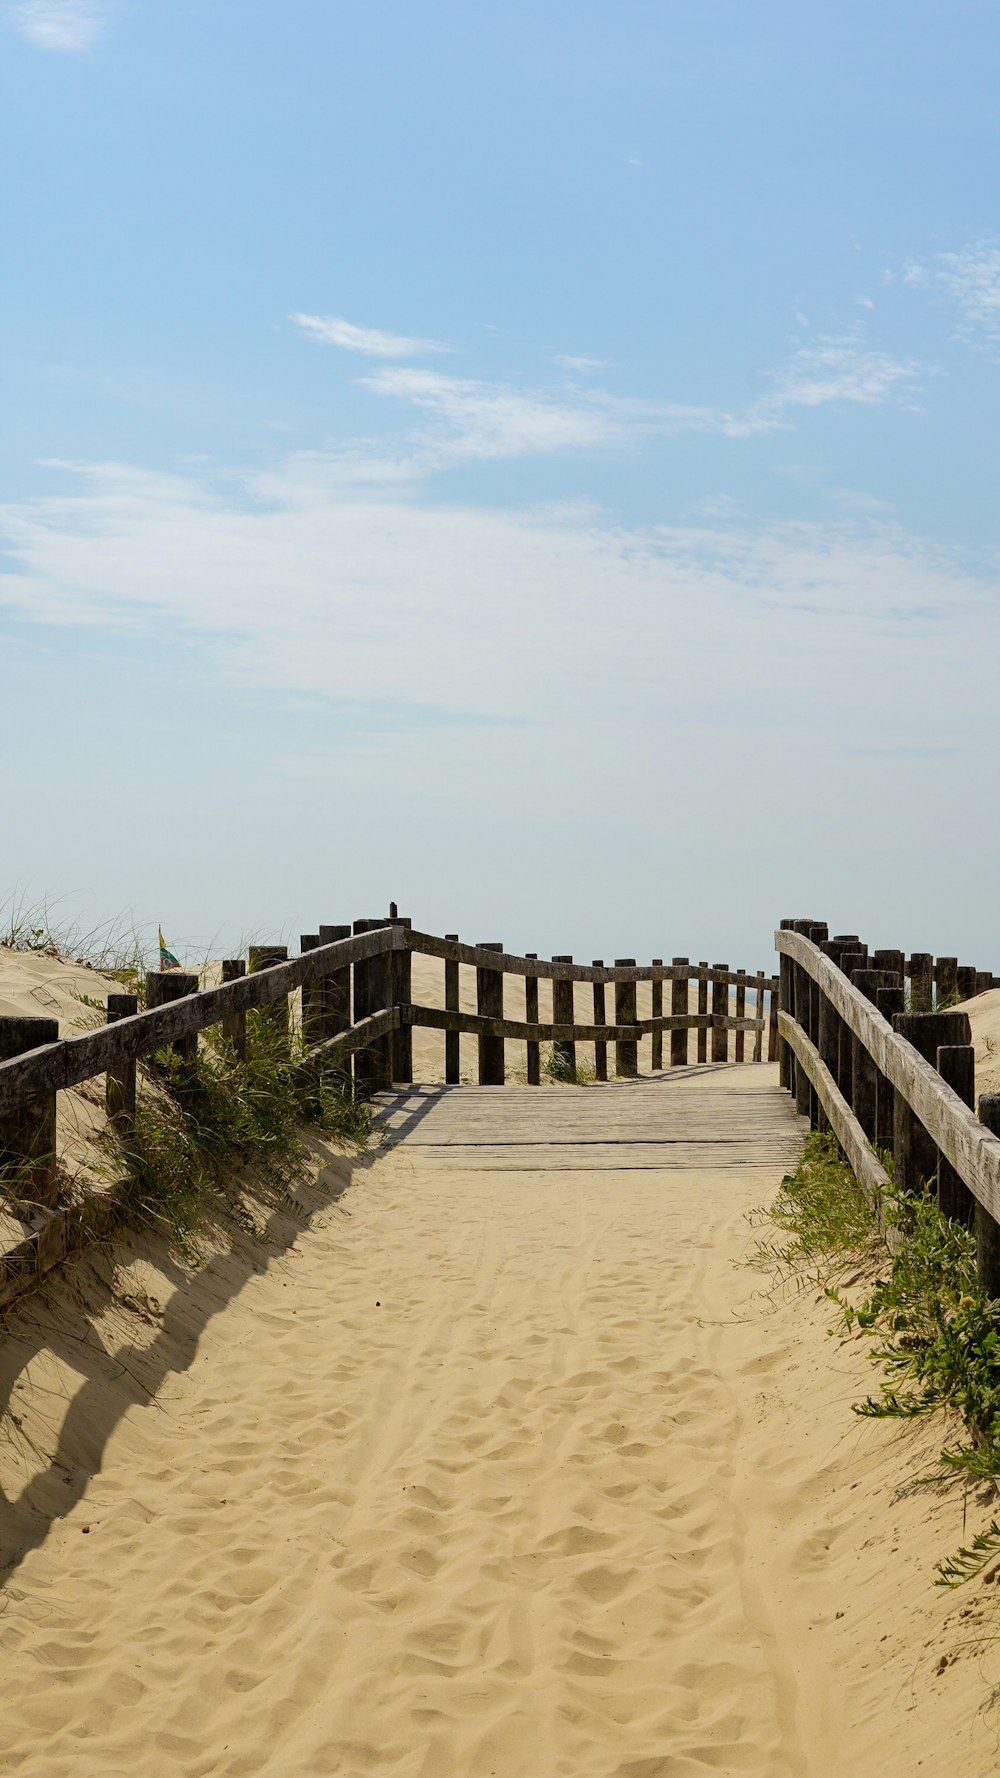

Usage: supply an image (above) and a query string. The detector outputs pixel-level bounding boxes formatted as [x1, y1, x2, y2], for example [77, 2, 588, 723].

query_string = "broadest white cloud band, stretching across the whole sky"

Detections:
[0, 457, 998, 746]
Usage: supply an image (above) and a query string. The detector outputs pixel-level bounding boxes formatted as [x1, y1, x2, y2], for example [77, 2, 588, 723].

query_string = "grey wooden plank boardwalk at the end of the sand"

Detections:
[379, 1063, 804, 1179]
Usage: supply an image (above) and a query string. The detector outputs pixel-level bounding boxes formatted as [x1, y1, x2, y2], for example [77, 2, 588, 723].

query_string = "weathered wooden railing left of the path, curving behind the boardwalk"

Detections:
[0, 909, 778, 1205]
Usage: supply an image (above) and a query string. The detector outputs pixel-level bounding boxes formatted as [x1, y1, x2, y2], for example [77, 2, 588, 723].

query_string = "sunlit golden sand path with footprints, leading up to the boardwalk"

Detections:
[0, 1070, 995, 1778]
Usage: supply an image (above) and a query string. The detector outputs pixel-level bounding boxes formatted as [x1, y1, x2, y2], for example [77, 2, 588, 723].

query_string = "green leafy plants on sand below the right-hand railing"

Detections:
[754, 1134, 1000, 1586]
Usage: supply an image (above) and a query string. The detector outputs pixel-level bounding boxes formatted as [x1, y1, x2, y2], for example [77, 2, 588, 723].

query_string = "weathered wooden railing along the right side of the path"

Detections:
[774, 919, 1000, 1296]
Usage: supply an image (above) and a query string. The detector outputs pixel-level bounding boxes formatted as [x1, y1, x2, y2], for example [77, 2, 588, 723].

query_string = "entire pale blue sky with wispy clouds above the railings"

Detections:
[0, 0, 1000, 969]
